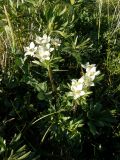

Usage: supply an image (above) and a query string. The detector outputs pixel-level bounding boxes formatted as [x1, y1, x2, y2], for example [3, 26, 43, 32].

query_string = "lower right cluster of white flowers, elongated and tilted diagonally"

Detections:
[70, 62, 100, 100]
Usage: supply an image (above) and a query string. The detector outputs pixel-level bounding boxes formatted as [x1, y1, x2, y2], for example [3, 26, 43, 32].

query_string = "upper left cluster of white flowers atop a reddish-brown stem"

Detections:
[24, 34, 60, 62]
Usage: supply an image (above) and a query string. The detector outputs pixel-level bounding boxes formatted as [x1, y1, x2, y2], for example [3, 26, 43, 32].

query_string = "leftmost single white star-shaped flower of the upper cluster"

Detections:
[24, 42, 37, 56]
